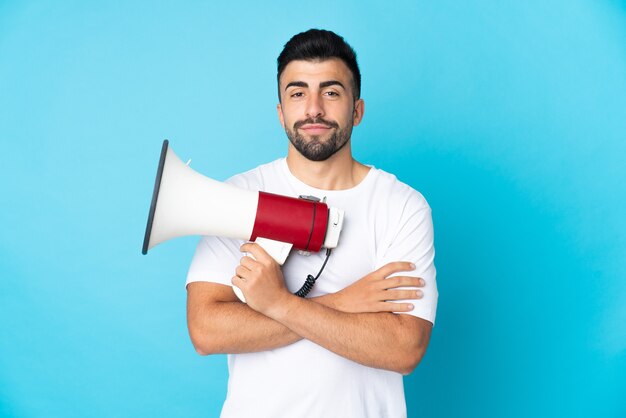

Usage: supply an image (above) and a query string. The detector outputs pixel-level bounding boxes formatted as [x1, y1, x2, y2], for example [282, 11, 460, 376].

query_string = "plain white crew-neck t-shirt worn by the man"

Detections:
[187, 158, 437, 418]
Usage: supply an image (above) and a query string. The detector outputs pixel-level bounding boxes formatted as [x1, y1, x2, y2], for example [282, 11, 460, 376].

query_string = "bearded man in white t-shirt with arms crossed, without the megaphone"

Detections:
[187, 29, 437, 418]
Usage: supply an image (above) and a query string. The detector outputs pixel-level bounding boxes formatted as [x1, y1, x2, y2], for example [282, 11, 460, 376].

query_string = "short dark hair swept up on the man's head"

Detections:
[276, 29, 361, 100]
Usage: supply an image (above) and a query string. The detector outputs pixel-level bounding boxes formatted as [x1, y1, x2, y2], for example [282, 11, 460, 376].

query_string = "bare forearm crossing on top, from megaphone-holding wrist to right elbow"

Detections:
[266, 297, 430, 374]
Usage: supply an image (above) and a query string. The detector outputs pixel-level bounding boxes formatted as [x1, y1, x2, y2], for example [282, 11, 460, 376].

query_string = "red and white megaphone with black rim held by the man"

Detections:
[142, 139, 344, 300]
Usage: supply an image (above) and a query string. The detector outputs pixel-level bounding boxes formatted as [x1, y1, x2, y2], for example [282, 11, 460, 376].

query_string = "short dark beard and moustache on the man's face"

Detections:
[285, 118, 352, 161]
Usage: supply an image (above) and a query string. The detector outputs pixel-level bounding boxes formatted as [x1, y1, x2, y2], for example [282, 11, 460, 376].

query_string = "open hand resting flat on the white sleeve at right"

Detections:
[331, 261, 425, 313]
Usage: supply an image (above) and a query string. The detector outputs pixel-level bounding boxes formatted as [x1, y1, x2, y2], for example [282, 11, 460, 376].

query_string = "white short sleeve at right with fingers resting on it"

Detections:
[376, 190, 438, 324]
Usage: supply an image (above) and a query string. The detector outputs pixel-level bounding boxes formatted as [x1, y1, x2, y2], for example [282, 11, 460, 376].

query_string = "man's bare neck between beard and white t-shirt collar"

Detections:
[287, 142, 370, 190]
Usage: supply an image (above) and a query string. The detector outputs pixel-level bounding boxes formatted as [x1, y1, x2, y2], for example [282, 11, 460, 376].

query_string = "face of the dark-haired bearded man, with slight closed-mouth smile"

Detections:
[278, 58, 363, 161]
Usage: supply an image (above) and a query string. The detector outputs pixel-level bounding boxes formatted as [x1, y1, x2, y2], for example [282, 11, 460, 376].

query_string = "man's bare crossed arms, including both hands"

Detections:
[187, 244, 432, 374]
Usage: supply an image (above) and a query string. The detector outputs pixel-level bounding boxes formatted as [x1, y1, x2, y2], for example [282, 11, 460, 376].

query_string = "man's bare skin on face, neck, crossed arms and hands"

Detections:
[187, 59, 432, 374]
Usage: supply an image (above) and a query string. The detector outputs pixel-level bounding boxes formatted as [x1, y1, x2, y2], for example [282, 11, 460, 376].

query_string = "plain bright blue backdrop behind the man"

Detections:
[0, 0, 626, 417]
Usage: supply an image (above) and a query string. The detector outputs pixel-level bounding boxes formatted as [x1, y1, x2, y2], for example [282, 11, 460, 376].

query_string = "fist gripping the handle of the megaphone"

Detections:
[231, 243, 292, 313]
